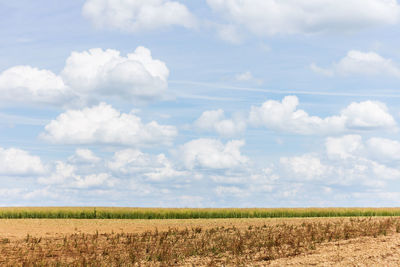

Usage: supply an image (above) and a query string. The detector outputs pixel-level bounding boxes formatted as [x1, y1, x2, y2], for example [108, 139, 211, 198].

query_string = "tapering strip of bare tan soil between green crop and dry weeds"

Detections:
[0, 218, 348, 240]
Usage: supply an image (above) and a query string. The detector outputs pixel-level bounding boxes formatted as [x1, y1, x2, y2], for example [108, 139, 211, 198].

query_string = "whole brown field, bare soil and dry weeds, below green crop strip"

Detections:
[0, 218, 400, 266]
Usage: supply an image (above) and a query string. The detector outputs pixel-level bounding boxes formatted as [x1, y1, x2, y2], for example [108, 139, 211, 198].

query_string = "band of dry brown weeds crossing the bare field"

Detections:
[0, 218, 400, 266]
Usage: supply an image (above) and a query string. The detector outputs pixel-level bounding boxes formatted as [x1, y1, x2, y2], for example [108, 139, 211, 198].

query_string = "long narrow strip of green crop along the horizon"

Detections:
[0, 207, 400, 219]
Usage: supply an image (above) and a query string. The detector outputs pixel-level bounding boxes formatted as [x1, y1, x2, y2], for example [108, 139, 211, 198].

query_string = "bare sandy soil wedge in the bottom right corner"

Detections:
[266, 234, 400, 266]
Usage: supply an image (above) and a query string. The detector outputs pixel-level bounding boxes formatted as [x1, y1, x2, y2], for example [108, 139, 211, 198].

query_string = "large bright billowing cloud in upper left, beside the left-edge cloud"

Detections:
[61, 47, 169, 100]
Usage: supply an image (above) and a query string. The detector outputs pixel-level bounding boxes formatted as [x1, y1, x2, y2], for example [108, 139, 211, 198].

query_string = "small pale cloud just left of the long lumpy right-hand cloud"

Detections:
[194, 109, 246, 137]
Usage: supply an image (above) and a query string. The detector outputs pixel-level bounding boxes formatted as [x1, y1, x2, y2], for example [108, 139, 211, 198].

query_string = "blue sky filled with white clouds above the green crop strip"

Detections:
[0, 0, 400, 207]
